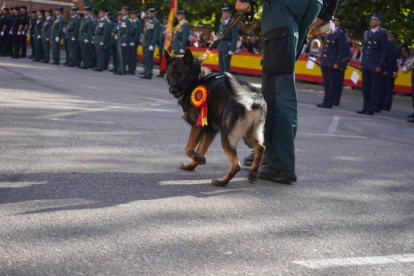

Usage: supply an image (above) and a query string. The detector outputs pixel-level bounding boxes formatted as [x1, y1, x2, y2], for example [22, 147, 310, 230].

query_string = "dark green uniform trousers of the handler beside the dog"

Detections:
[262, 0, 322, 171]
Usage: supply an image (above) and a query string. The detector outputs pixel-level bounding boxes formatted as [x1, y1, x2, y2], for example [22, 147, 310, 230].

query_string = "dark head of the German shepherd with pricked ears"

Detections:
[164, 49, 201, 98]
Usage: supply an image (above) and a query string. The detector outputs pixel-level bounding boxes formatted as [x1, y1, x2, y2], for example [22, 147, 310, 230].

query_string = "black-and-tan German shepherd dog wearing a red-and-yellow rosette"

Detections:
[164, 49, 267, 187]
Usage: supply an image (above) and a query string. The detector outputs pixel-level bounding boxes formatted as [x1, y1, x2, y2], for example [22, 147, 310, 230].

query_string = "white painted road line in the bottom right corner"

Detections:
[293, 254, 414, 269]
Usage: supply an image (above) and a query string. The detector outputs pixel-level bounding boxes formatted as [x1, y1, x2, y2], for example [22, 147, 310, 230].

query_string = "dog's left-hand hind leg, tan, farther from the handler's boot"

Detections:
[211, 133, 241, 187]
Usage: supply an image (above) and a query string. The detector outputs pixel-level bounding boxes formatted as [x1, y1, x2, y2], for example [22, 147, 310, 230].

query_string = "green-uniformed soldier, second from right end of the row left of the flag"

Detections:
[126, 11, 142, 75]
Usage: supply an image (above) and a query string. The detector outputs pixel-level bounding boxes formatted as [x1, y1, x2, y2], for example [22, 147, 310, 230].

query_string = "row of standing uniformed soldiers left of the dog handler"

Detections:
[0, 6, 238, 79]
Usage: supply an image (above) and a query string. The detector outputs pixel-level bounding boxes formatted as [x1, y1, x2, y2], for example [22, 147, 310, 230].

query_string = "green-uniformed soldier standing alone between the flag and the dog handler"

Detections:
[217, 7, 239, 74]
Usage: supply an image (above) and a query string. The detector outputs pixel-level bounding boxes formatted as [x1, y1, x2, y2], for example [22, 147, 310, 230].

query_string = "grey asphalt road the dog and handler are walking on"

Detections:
[0, 58, 414, 276]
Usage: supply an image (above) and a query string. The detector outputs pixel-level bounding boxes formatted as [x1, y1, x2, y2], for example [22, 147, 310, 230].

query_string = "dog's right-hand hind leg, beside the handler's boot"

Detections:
[244, 122, 266, 183]
